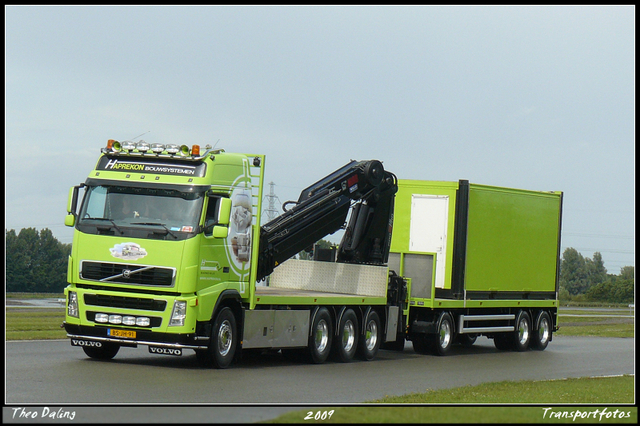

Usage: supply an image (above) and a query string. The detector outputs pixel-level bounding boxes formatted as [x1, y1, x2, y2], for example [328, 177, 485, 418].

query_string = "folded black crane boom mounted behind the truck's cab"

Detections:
[257, 160, 398, 280]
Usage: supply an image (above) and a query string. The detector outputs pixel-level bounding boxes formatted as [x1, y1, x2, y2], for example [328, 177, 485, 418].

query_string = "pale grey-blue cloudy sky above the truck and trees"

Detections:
[5, 6, 636, 274]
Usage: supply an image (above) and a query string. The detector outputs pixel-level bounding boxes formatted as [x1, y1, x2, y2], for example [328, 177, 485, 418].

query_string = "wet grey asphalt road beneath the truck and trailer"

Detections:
[3, 336, 635, 423]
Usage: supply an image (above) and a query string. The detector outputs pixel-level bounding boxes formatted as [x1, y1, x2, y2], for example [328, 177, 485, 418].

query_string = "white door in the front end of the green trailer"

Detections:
[409, 194, 449, 288]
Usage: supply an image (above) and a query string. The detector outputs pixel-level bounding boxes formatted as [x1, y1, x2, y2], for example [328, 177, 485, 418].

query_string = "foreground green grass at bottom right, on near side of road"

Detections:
[264, 376, 638, 424]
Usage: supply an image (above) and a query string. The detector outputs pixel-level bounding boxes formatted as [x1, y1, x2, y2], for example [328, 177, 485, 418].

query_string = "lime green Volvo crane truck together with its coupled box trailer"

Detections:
[63, 140, 562, 368]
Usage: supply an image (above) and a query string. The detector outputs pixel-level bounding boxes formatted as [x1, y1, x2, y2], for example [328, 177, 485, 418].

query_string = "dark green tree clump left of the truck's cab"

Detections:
[5, 228, 71, 293]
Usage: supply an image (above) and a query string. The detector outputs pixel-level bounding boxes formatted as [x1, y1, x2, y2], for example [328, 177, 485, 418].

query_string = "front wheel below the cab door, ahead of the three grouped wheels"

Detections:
[196, 307, 237, 368]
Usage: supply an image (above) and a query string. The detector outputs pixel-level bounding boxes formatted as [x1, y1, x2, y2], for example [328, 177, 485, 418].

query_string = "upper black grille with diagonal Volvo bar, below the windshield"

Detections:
[80, 261, 175, 287]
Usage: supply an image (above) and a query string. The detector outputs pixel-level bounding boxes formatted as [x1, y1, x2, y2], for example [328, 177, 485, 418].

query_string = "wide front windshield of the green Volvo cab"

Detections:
[78, 185, 204, 239]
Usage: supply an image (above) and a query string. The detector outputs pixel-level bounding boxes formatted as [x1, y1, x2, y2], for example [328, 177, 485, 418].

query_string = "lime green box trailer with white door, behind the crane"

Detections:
[389, 180, 562, 350]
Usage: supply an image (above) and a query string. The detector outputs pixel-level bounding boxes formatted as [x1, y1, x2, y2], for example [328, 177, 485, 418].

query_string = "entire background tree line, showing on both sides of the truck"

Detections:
[5, 228, 635, 303]
